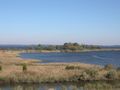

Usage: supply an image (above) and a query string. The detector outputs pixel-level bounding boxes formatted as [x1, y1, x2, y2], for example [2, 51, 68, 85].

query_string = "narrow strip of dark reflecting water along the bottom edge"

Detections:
[0, 81, 120, 90]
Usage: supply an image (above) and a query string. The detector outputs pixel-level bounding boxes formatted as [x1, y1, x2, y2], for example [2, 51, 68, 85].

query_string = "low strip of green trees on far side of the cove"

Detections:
[35, 43, 100, 51]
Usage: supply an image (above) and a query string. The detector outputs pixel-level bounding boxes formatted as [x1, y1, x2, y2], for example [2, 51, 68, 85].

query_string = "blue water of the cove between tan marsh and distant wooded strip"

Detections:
[21, 51, 120, 66]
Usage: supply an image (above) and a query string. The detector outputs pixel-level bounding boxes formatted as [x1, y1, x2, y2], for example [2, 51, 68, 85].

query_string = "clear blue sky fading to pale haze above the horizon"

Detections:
[0, 0, 120, 45]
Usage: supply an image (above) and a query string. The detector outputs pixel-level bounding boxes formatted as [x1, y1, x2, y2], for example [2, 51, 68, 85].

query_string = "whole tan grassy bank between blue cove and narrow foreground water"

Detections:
[0, 51, 120, 83]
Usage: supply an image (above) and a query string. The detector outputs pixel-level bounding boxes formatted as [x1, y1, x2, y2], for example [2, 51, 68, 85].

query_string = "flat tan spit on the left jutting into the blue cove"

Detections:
[0, 50, 41, 65]
